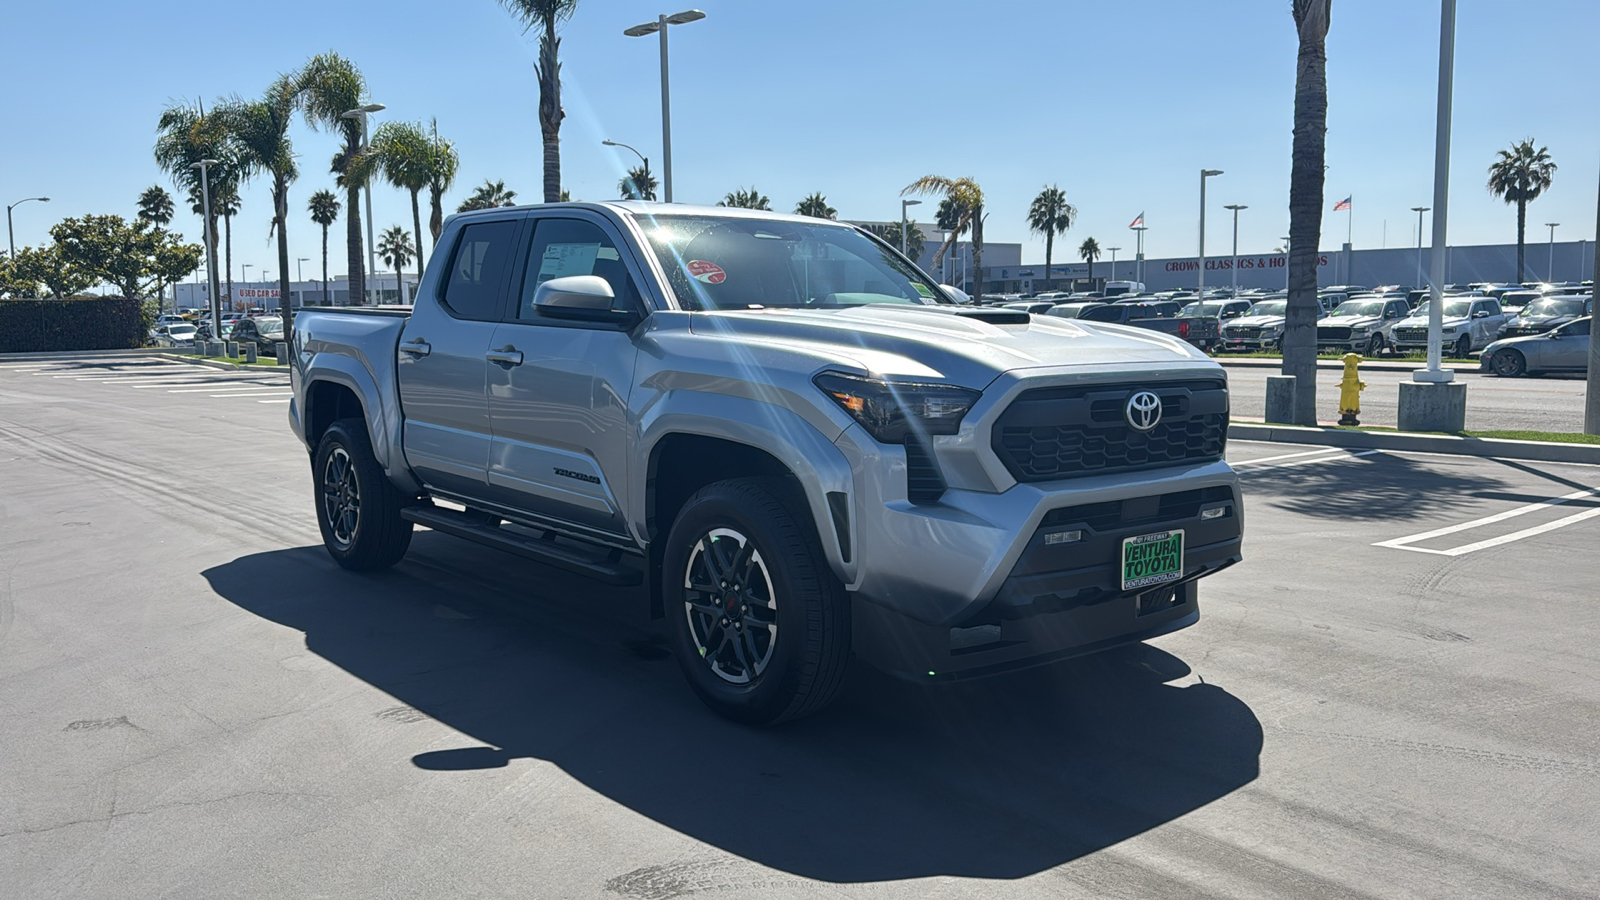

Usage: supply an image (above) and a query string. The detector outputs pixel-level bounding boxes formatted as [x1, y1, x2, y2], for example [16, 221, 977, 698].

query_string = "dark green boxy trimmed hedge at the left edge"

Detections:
[0, 296, 146, 352]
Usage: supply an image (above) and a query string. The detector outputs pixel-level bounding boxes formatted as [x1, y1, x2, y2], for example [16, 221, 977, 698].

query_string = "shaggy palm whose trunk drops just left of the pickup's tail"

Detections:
[218, 75, 301, 331]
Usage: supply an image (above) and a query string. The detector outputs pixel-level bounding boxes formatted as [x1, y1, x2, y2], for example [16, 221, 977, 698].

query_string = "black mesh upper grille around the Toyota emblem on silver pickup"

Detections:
[994, 381, 1227, 482]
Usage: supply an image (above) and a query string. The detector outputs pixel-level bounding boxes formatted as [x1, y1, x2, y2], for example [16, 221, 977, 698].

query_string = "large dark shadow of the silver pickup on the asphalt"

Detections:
[205, 532, 1262, 877]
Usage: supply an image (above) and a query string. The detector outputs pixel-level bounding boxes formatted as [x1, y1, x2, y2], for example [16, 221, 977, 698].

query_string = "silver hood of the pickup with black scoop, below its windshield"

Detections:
[690, 304, 1208, 389]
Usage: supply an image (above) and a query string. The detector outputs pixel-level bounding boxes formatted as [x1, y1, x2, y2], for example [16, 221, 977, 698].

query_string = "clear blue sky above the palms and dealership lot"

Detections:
[0, 0, 1600, 277]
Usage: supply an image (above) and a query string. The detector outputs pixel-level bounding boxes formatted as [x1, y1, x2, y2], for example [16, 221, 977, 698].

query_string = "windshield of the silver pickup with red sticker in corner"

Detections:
[642, 216, 944, 309]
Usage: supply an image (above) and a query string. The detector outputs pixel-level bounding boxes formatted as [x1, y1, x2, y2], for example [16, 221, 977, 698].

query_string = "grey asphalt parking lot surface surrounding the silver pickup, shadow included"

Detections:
[0, 359, 1600, 900]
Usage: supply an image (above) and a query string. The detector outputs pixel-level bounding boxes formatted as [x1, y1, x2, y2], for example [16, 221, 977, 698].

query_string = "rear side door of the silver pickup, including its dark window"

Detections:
[398, 216, 522, 500]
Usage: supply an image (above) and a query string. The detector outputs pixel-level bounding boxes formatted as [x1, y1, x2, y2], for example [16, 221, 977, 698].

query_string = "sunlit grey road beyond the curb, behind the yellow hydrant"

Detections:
[1219, 357, 1584, 431]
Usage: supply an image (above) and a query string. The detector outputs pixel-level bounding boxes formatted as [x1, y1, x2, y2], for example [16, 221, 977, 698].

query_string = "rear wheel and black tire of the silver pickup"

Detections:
[310, 418, 411, 572]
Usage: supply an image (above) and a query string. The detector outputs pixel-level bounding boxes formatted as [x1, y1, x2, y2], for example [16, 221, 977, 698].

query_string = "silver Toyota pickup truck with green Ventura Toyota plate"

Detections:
[290, 202, 1242, 724]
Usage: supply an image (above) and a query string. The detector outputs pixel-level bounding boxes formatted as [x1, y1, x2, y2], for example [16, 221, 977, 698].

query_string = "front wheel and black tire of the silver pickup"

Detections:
[661, 479, 850, 725]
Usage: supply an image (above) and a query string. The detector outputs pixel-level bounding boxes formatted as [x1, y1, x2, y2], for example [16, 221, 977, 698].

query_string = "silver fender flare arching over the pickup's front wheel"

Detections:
[627, 391, 858, 585]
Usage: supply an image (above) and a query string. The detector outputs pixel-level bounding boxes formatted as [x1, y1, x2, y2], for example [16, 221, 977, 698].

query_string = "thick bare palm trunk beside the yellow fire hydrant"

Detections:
[1282, 0, 1333, 426]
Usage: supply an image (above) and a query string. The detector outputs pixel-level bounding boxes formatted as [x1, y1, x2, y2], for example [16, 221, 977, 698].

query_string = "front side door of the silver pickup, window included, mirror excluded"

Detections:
[488, 210, 650, 541]
